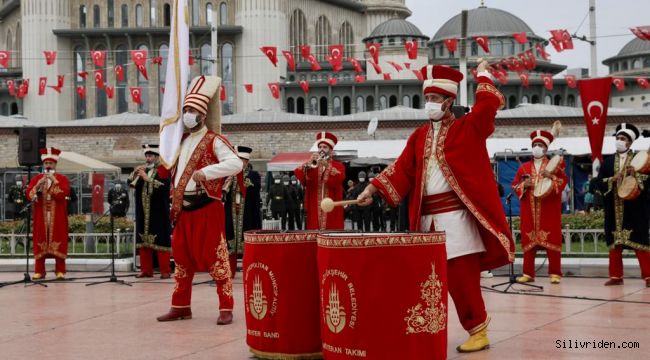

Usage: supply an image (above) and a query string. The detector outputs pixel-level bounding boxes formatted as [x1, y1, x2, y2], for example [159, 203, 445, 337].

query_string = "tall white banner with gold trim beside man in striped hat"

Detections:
[160, 0, 190, 169]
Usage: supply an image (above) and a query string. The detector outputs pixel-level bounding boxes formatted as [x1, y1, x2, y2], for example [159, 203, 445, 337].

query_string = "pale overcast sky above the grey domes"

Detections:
[406, 0, 650, 76]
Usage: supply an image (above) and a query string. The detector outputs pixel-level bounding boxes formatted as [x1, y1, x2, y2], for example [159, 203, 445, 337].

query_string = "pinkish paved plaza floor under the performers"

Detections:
[0, 272, 650, 360]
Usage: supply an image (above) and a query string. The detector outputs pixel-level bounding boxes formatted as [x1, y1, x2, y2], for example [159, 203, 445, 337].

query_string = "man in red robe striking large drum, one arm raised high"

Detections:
[358, 61, 514, 352]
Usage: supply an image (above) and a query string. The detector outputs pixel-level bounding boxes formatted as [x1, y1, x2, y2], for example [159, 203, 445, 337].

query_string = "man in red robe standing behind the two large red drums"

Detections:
[294, 131, 345, 230]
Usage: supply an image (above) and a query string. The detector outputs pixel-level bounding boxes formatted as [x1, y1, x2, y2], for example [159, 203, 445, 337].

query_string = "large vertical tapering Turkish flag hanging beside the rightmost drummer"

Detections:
[578, 77, 612, 162]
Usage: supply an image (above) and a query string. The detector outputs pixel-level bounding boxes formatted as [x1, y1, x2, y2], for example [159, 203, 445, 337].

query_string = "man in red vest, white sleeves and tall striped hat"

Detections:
[158, 76, 242, 325]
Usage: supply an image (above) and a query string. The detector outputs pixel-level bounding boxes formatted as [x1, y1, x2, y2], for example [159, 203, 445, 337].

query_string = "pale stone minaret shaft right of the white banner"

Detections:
[234, 0, 289, 113]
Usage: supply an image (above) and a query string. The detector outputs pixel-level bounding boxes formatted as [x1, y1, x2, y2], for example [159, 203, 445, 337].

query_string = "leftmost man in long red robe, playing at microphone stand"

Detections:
[26, 147, 70, 280]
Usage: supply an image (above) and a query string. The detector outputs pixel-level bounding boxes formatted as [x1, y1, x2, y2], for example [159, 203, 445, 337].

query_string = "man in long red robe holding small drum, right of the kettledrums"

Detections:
[512, 130, 567, 284]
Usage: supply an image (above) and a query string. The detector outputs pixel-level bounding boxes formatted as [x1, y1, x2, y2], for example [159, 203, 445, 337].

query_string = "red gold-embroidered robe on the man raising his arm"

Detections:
[372, 76, 514, 270]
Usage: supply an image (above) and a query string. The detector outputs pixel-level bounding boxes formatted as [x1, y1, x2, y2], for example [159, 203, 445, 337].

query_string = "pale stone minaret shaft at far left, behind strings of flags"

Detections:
[20, 0, 74, 122]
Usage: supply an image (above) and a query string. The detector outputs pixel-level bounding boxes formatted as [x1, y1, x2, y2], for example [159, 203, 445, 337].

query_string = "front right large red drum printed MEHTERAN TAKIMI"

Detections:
[318, 233, 447, 360]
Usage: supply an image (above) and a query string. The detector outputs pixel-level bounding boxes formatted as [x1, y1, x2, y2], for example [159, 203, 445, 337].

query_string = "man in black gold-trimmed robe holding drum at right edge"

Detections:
[596, 123, 650, 287]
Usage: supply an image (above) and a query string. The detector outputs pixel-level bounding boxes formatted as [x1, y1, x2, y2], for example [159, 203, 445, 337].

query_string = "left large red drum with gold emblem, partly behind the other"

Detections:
[243, 231, 322, 359]
